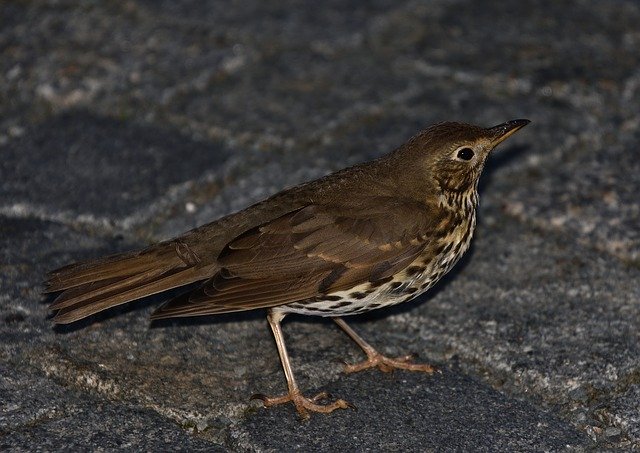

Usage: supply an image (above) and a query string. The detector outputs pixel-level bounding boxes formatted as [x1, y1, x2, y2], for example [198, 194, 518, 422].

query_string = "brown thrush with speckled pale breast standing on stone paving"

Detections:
[45, 119, 529, 418]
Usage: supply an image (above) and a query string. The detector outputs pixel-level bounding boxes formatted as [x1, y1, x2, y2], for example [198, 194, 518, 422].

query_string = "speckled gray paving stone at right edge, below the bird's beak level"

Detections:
[490, 125, 640, 267]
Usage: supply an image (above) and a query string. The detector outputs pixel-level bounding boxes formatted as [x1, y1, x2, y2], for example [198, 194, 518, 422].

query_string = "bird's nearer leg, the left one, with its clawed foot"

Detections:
[252, 310, 352, 419]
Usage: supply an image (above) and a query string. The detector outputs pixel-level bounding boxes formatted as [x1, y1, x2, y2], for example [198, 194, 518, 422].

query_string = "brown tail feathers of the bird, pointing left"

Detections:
[44, 240, 216, 324]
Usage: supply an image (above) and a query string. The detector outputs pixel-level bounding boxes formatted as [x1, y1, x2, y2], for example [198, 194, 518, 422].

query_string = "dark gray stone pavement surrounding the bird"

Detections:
[0, 0, 640, 451]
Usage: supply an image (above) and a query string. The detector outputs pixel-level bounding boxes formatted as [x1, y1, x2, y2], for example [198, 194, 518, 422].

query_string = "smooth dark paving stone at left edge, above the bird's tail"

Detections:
[0, 112, 228, 225]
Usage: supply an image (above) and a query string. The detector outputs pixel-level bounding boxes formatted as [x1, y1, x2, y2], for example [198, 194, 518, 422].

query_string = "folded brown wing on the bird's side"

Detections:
[153, 196, 442, 319]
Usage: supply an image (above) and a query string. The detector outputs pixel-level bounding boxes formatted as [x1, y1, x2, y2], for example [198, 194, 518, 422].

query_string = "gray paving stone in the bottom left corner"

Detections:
[0, 364, 225, 451]
